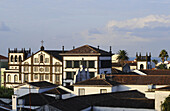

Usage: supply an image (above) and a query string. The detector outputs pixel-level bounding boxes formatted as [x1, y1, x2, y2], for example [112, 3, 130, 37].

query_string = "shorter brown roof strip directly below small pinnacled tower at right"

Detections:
[140, 69, 170, 75]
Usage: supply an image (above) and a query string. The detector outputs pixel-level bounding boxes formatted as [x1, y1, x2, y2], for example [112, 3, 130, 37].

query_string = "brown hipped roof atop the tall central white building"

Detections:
[61, 45, 111, 55]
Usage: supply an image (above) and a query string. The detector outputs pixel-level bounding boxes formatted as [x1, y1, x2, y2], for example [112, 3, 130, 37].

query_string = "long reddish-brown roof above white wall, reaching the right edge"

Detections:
[107, 75, 170, 85]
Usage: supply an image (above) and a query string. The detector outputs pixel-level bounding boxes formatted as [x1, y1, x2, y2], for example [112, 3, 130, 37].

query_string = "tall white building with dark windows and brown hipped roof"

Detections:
[60, 45, 112, 85]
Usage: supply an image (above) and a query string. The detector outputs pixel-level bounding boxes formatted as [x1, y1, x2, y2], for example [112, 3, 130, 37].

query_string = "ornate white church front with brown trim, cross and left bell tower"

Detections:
[4, 46, 62, 87]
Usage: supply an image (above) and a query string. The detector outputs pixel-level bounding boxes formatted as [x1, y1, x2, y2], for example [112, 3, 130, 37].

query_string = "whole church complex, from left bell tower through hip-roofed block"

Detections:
[4, 41, 112, 88]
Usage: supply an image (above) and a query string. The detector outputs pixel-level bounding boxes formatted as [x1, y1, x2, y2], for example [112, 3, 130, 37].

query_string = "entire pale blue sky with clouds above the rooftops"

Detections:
[0, 0, 170, 57]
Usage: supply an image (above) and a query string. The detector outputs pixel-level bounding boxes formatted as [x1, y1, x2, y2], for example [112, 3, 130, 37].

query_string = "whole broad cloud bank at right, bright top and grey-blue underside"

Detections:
[76, 15, 170, 55]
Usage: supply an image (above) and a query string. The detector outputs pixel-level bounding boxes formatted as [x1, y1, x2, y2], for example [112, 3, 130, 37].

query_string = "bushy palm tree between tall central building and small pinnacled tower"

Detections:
[117, 50, 129, 66]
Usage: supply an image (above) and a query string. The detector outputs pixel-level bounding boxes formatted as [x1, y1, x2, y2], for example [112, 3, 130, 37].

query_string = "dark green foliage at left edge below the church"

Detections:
[0, 87, 14, 98]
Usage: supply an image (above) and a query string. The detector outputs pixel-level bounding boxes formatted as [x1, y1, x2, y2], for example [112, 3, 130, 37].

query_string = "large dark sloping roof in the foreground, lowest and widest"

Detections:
[49, 90, 154, 111]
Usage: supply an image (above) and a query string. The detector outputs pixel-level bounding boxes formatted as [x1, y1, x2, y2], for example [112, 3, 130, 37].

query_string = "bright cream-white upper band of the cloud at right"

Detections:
[107, 15, 170, 29]
